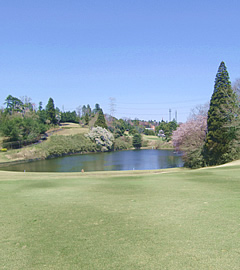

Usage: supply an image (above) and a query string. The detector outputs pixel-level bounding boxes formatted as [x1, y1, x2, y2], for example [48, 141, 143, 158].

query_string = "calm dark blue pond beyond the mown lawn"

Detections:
[1, 149, 183, 172]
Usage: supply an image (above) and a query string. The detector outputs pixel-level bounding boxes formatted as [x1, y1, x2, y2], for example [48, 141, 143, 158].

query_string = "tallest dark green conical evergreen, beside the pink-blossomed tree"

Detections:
[203, 62, 238, 165]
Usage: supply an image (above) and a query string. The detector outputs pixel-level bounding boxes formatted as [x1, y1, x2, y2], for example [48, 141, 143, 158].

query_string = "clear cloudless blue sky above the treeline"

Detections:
[0, 0, 240, 121]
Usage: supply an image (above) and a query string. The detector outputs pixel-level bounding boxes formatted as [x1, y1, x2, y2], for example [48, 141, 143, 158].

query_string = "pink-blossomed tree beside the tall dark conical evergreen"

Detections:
[172, 115, 207, 168]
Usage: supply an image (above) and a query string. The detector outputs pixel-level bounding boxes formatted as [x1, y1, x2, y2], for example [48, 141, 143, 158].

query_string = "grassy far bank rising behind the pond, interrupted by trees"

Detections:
[0, 129, 173, 163]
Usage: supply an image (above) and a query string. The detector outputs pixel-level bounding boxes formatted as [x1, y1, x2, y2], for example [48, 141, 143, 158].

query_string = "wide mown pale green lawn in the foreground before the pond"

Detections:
[0, 165, 240, 270]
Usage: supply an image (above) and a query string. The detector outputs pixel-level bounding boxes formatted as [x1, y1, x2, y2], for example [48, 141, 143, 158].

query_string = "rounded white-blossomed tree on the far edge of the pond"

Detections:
[87, 127, 114, 152]
